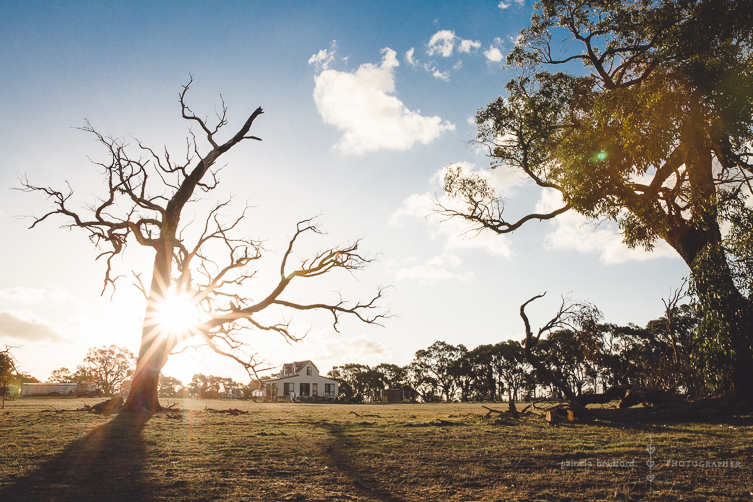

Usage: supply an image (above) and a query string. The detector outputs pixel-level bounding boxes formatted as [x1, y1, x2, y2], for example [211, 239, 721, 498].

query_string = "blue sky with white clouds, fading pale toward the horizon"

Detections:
[0, 0, 687, 380]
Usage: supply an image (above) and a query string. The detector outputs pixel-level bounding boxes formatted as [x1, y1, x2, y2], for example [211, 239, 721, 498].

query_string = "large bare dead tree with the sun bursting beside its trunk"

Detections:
[20, 76, 389, 411]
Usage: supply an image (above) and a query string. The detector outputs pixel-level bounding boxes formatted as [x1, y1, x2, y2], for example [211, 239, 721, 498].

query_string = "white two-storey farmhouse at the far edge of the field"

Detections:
[264, 361, 338, 399]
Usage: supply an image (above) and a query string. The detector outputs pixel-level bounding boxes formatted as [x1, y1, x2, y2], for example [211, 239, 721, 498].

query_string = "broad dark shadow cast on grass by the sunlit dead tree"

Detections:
[0, 413, 152, 502]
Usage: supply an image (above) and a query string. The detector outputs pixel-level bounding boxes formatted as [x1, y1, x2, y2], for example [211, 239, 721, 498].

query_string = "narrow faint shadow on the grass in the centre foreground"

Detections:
[320, 422, 404, 502]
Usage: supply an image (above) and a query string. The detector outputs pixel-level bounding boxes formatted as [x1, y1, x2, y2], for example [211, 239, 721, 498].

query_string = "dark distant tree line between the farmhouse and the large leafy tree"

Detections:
[327, 305, 711, 402]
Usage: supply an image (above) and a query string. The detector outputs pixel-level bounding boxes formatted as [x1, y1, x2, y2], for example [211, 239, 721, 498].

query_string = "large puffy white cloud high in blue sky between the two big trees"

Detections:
[314, 48, 455, 154]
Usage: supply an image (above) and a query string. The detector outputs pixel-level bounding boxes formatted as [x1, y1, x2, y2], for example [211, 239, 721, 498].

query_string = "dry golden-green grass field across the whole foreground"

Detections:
[0, 398, 753, 502]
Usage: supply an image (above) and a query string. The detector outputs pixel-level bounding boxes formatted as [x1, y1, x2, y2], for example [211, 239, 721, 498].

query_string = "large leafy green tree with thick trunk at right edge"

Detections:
[438, 0, 753, 401]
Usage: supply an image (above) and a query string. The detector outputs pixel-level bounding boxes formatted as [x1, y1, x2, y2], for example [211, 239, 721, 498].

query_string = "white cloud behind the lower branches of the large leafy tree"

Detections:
[536, 190, 678, 264]
